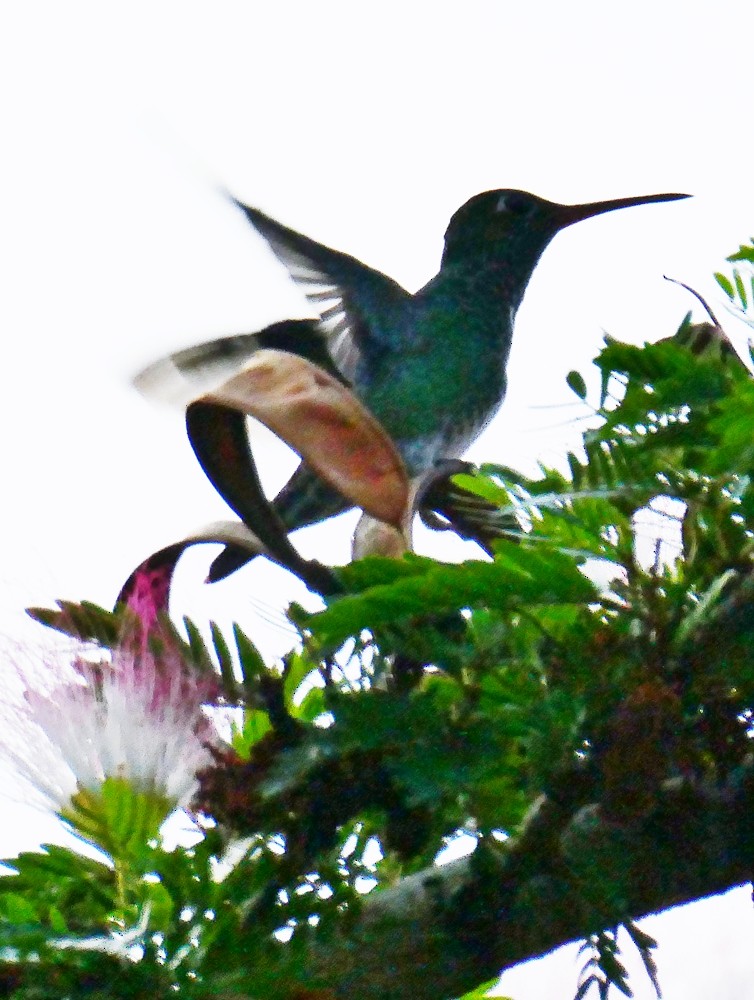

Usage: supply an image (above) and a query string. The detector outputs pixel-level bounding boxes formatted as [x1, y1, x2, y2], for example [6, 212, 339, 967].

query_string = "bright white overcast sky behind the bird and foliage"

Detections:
[0, 0, 754, 1000]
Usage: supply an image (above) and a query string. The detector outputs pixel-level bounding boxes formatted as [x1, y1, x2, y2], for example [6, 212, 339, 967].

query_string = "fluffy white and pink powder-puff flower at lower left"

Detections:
[0, 648, 218, 849]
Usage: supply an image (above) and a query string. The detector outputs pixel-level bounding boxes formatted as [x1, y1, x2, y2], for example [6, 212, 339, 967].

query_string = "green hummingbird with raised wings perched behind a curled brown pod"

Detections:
[137, 189, 689, 580]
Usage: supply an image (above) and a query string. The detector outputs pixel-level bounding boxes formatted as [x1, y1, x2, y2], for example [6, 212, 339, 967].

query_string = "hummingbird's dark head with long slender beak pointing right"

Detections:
[442, 189, 690, 292]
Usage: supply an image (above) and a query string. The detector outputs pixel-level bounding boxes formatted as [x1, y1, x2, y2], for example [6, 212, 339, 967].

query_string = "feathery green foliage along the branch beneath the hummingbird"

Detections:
[11, 300, 754, 1000]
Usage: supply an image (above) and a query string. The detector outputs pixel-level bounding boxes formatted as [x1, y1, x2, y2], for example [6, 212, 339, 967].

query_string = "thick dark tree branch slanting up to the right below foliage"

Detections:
[300, 765, 754, 1000]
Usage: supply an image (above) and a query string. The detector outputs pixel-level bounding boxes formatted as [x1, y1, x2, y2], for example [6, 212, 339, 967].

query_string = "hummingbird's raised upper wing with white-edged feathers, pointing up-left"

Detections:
[236, 201, 412, 381]
